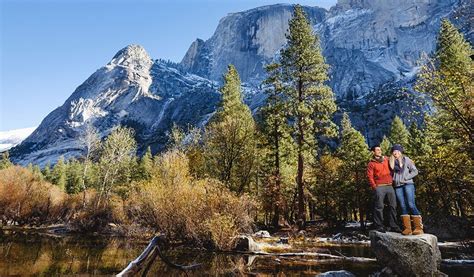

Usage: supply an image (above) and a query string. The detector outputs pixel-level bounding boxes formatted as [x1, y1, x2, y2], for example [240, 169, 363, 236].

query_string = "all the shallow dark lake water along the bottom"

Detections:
[0, 230, 473, 276]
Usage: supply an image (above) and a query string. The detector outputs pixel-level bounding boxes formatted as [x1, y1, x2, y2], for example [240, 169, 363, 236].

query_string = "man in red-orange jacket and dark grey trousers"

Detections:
[367, 145, 402, 233]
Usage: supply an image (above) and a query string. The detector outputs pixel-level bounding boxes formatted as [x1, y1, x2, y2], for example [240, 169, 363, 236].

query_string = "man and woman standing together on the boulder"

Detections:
[367, 144, 423, 235]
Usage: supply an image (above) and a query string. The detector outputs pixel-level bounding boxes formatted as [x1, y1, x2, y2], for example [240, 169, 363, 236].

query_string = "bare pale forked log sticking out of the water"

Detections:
[117, 235, 201, 276]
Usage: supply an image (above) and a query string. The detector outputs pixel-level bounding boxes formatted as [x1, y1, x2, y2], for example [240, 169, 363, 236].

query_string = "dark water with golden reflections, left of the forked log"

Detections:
[0, 230, 143, 276]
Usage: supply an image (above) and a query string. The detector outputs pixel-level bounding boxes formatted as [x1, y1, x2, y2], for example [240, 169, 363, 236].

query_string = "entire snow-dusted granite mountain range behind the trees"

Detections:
[11, 0, 474, 164]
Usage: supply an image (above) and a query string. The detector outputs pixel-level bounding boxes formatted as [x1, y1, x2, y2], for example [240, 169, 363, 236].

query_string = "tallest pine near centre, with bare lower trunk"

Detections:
[280, 5, 335, 228]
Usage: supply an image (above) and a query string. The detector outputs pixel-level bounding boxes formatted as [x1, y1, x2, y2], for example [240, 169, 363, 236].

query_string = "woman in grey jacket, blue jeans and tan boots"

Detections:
[389, 144, 423, 235]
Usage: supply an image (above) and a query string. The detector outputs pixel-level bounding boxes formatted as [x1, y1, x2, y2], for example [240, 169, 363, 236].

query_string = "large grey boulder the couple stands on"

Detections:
[370, 231, 441, 276]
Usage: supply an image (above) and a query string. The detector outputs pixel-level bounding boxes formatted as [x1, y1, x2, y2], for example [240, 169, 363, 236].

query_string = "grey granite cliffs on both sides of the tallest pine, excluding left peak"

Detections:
[181, 0, 468, 140]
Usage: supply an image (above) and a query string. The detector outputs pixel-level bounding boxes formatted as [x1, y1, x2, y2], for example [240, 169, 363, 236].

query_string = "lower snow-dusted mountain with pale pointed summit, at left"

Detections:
[10, 45, 218, 165]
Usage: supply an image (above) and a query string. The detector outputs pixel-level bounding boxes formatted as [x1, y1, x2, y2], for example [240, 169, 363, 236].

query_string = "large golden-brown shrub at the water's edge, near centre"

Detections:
[127, 150, 253, 249]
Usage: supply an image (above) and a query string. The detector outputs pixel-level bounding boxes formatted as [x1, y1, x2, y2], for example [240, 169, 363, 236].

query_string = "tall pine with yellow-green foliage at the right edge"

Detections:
[415, 19, 474, 217]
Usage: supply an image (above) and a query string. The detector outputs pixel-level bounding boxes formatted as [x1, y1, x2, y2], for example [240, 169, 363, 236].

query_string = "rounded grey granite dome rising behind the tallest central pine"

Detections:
[181, 4, 327, 85]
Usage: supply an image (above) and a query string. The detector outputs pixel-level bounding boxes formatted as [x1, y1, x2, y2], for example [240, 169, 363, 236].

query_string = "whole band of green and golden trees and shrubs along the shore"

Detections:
[0, 6, 474, 249]
